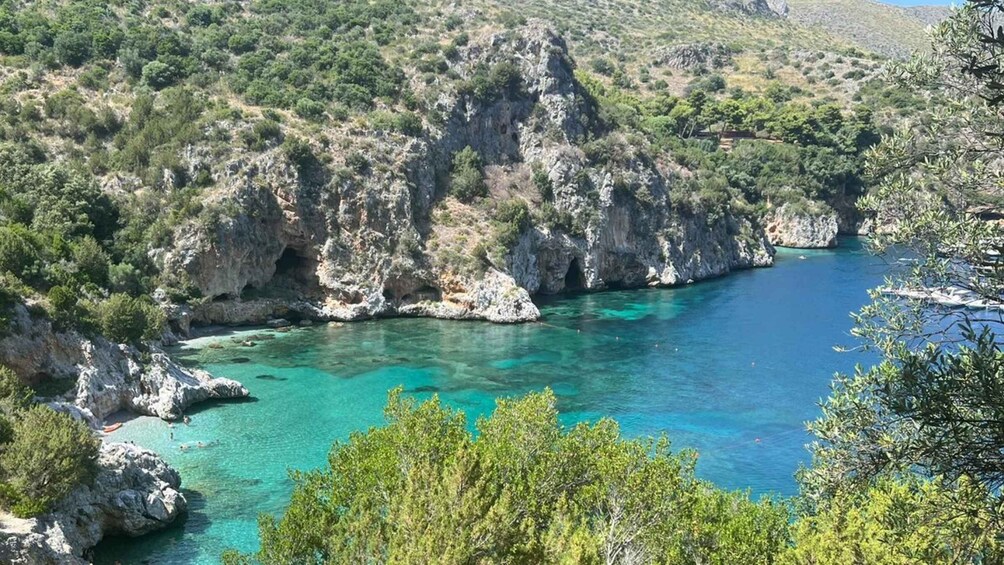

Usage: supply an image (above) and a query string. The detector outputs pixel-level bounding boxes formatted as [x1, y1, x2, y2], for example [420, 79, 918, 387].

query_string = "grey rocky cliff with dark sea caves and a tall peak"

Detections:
[159, 22, 772, 331]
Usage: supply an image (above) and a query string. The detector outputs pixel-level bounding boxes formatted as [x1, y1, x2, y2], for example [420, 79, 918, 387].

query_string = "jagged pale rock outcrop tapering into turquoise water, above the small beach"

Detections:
[0, 305, 248, 426]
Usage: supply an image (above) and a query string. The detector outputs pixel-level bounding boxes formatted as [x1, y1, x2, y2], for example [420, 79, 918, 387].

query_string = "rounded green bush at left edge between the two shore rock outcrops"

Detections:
[0, 366, 99, 517]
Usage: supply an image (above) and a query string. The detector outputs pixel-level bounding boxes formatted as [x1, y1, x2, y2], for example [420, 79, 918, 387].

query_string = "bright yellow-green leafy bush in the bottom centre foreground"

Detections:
[227, 389, 788, 564]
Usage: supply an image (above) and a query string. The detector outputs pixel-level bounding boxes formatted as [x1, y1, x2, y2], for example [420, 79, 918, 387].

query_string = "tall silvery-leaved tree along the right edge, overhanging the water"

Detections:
[800, 2, 1004, 549]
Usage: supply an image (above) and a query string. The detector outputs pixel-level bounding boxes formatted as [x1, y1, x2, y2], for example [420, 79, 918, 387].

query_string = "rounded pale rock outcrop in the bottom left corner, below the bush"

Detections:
[0, 444, 188, 565]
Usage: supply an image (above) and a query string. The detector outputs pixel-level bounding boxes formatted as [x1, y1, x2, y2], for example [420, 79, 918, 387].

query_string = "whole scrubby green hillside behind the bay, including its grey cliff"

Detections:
[0, 0, 924, 340]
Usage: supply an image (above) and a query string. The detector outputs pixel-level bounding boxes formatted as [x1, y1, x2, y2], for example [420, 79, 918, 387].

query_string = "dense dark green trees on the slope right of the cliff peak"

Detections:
[580, 75, 880, 212]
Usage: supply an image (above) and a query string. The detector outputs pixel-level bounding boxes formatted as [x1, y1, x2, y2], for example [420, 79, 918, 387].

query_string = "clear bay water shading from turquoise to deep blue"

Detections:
[95, 240, 886, 563]
